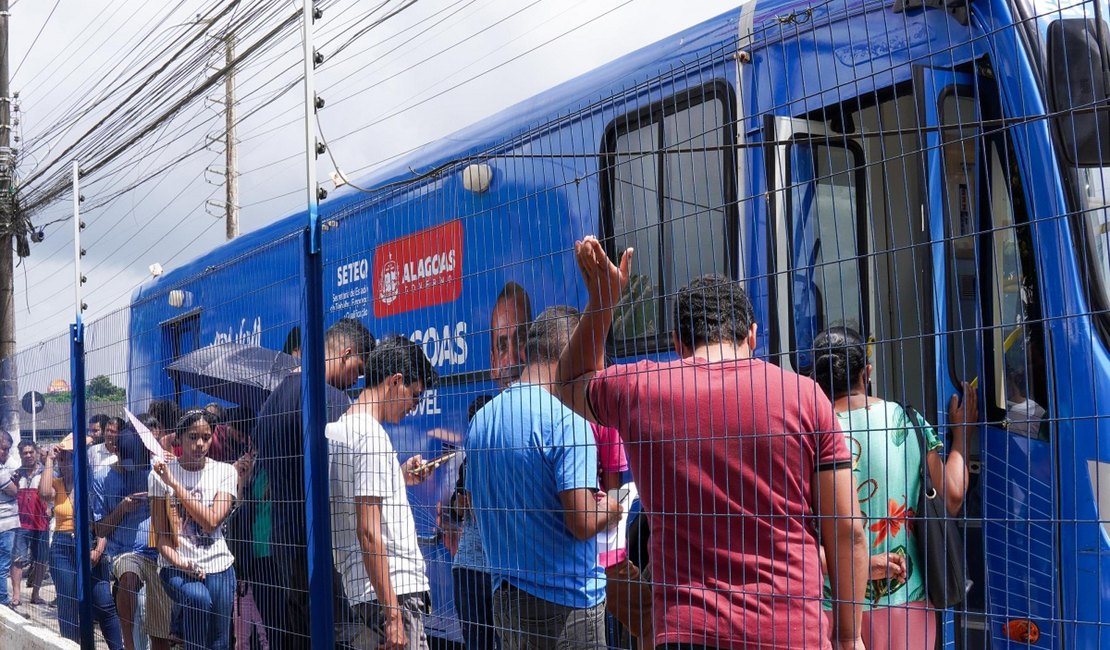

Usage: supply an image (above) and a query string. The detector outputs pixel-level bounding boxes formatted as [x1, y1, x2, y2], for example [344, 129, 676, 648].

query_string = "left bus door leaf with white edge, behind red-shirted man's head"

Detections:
[765, 118, 870, 373]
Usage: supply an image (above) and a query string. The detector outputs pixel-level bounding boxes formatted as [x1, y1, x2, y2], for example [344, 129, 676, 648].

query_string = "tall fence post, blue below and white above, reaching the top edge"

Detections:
[301, 0, 335, 648]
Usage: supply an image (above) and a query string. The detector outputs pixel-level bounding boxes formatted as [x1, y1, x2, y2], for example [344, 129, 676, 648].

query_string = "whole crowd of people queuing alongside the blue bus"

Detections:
[0, 230, 978, 650]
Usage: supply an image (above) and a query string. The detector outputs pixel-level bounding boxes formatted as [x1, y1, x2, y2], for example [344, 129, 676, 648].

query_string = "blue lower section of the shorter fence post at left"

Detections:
[70, 316, 95, 648]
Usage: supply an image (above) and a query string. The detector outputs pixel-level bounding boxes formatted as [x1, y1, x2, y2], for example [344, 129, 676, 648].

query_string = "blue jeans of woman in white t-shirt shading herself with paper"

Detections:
[159, 567, 235, 650]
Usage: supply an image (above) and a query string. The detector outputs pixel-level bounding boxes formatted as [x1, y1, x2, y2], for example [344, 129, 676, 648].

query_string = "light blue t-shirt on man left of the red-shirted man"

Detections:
[466, 384, 605, 609]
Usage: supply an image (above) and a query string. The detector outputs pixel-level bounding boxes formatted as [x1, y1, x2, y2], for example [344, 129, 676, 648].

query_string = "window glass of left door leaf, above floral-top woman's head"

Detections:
[787, 141, 868, 372]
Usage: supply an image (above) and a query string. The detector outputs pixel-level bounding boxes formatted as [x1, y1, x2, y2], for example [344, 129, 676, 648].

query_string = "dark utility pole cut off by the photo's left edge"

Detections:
[0, 0, 19, 437]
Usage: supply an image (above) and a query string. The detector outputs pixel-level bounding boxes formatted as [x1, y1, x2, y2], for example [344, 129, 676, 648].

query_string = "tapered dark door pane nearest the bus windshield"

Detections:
[989, 145, 1048, 439]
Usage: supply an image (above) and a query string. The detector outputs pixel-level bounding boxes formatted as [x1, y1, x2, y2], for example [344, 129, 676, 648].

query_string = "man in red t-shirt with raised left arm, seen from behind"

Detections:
[557, 237, 868, 650]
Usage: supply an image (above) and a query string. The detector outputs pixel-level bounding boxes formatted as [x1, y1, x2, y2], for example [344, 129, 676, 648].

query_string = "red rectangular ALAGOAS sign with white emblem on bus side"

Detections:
[373, 220, 463, 318]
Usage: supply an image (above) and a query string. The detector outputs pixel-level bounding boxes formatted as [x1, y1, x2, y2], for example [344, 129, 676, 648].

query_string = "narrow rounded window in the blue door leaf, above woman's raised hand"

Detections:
[939, 87, 979, 385]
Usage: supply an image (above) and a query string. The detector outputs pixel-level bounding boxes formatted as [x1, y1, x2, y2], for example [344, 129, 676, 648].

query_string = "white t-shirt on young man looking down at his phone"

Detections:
[326, 405, 430, 603]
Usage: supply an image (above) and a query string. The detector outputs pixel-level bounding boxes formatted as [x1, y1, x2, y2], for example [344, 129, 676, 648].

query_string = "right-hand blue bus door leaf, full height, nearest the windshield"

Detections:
[914, 67, 1058, 649]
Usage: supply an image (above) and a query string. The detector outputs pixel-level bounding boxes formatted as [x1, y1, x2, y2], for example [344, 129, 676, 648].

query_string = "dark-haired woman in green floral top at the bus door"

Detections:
[813, 327, 978, 650]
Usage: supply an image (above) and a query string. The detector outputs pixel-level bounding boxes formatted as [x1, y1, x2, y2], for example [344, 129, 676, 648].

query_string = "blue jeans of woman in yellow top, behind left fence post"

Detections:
[50, 532, 123, 650]
